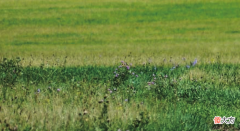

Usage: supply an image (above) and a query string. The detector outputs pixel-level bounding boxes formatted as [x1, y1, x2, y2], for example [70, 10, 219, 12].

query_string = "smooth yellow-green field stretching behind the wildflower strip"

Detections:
[0, 0, 240, 66]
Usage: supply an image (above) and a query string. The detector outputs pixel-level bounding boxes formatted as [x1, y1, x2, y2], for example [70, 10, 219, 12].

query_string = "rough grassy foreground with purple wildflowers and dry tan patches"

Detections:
[0, 59, 240, 131]
